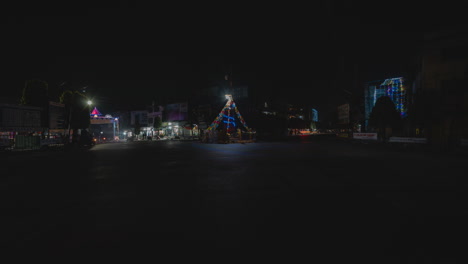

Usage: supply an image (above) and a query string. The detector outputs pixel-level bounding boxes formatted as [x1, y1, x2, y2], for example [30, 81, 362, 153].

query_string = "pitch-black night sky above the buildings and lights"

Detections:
[1, 1, 464, 114]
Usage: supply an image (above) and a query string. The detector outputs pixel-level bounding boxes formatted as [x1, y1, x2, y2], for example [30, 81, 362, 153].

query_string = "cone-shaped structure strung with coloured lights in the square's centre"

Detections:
[206, 94, 251, 134]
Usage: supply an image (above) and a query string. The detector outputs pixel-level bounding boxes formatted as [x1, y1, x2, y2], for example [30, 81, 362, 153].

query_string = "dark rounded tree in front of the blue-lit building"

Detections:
[369, 96, 401, 141]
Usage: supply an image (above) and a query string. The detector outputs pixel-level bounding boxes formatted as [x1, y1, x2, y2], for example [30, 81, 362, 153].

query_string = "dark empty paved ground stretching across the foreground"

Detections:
[0, 138, 468, 263]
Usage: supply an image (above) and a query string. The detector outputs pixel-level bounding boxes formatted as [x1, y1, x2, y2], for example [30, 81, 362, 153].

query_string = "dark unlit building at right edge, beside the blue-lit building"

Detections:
[408, 27, 468, 148]
